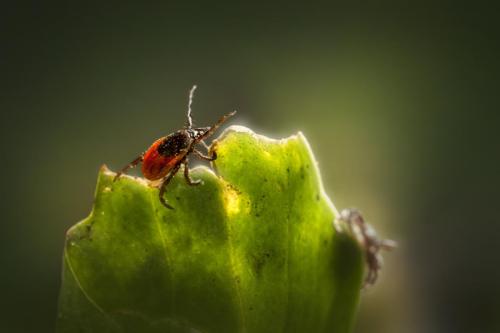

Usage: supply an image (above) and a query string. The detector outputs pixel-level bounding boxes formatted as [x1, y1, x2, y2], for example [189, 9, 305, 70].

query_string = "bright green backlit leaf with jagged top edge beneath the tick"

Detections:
[57, 126, 363, 333]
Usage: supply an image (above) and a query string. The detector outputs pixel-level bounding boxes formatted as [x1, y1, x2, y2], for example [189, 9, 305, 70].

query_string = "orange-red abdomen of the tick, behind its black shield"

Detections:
[142, 138, 183, 180]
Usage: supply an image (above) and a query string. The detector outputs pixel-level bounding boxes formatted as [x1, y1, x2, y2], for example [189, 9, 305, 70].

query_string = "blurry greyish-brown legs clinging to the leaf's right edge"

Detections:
[339, 209, 396, 287]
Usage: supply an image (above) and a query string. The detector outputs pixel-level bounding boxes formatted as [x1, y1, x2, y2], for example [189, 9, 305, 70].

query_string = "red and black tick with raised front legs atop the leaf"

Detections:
[113, 86, 236, 209]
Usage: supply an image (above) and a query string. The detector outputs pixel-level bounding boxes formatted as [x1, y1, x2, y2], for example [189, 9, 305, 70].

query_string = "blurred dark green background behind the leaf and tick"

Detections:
[0, 1, 500, 333]
